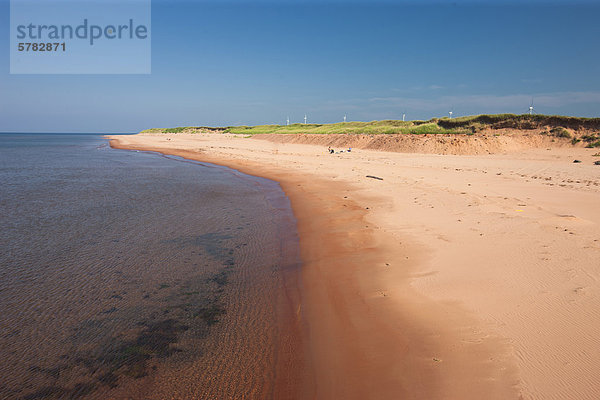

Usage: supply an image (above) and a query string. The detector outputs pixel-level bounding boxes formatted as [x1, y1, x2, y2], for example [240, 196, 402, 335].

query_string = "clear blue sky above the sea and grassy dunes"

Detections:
[0, 0, 600, 132]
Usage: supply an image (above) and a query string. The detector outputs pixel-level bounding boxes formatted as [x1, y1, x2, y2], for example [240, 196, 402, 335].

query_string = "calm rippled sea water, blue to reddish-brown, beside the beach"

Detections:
[0, 134, 299, 399]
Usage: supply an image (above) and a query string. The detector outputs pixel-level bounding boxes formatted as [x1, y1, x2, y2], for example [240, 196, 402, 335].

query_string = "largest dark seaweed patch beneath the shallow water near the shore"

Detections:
[33, 241, 234, 400]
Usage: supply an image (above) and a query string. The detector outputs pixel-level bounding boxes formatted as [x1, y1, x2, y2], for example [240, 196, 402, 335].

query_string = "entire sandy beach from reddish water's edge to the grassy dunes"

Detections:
[112, 134, 600, 399]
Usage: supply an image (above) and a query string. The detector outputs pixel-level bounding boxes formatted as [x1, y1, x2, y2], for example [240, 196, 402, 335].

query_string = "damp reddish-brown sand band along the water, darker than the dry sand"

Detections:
[110, 135, 519, 399]
